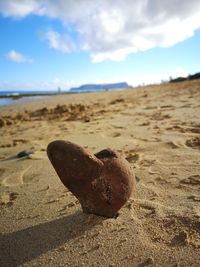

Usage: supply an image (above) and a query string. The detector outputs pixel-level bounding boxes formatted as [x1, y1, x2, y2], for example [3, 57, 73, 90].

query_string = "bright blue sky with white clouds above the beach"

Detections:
[0, 0, 200, 91]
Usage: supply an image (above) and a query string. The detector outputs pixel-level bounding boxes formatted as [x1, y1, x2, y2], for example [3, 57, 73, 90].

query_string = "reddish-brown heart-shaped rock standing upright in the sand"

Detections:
[47, 140, 136, 217]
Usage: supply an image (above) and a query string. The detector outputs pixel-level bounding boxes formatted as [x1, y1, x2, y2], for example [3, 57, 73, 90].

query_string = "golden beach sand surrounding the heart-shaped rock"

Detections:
[0, 81, 200, 267]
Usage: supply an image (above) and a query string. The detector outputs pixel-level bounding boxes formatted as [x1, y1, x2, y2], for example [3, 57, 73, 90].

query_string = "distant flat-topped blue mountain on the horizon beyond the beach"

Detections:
[69, 82, 129, 92]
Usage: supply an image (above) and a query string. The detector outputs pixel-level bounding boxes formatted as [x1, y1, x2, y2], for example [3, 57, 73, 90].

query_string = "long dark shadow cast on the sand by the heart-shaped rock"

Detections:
[0, 211, 106, 267]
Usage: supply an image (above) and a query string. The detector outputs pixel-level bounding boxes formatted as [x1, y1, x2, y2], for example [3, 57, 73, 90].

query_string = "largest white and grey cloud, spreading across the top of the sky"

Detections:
[0, 0, 200, 62]
